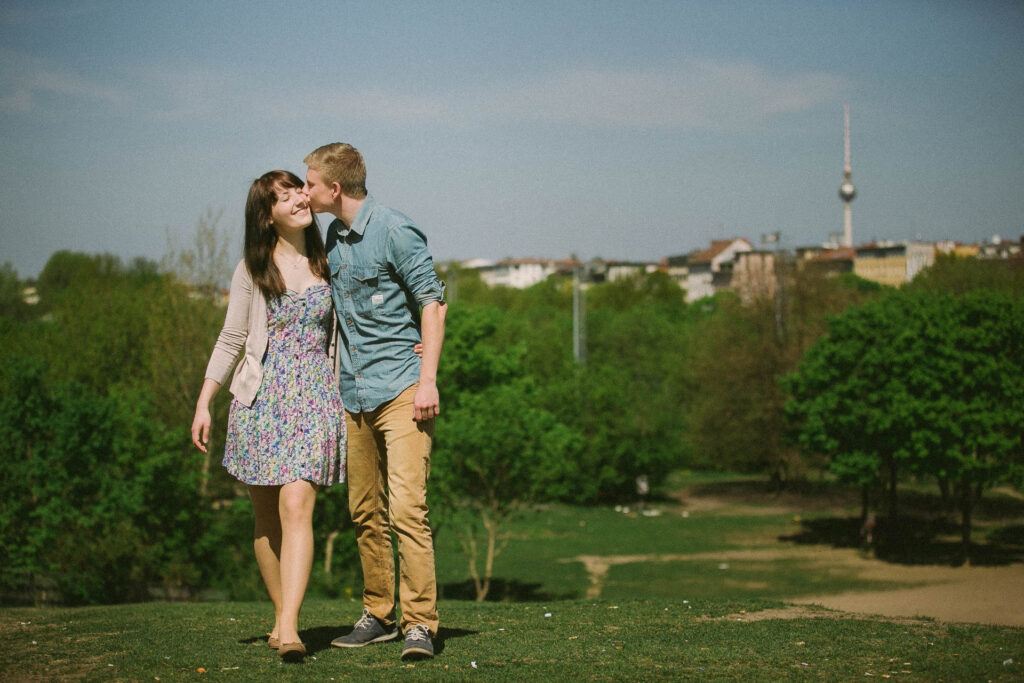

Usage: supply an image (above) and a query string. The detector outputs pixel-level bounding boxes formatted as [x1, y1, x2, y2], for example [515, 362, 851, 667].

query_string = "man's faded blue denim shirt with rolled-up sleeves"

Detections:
[326, 195, 444, 413]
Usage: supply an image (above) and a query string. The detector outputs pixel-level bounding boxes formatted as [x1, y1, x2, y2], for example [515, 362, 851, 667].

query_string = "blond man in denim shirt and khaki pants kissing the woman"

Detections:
[305, 142, 445, 659]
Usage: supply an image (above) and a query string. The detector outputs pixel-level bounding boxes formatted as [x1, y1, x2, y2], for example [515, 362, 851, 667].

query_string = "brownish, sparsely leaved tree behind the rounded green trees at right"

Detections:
[686, 268, 878, 485]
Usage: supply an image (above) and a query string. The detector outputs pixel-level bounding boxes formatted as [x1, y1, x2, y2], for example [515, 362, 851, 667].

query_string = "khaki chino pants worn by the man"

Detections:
[346, 384, 437, 634]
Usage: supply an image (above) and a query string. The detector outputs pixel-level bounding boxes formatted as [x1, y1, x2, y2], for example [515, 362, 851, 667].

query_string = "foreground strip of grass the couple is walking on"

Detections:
[0, 599, 1024, 681]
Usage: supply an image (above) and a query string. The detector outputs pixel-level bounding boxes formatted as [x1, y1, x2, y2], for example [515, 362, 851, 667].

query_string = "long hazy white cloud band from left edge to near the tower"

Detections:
[0, 50, 849, 128]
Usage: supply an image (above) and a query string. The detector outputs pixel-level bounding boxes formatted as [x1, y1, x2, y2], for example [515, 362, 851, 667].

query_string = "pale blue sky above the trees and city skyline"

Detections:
[0, 0, 1024, 276]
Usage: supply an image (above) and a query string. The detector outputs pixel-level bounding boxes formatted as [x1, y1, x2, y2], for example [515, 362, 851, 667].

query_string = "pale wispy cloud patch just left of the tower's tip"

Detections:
[474, 61, 847, 128]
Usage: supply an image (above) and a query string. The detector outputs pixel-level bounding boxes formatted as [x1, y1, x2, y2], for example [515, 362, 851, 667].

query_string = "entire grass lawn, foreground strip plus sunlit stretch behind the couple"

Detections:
[0, 481, 1024, 681]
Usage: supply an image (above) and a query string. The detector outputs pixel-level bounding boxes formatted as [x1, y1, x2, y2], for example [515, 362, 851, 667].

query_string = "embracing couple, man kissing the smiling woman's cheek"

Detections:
[191, 142, 446, 660]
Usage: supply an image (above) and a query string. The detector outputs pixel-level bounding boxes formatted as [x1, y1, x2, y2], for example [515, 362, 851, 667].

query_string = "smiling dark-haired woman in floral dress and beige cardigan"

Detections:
[191, 171, 346, 660]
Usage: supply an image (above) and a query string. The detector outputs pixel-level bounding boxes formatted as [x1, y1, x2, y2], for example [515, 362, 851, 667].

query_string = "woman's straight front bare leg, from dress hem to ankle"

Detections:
[279, 480, 317, 643]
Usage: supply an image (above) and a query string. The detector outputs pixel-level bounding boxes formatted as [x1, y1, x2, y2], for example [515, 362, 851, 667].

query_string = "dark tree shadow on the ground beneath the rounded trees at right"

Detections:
[779, 513, 1024, 566]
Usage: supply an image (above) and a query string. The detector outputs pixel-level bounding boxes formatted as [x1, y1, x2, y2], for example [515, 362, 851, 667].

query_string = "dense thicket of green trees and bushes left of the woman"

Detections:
[0, 246, 251, 602]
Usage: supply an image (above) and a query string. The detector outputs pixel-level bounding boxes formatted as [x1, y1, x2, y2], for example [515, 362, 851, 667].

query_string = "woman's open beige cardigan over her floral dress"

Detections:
[206, 260, 338, 407]
